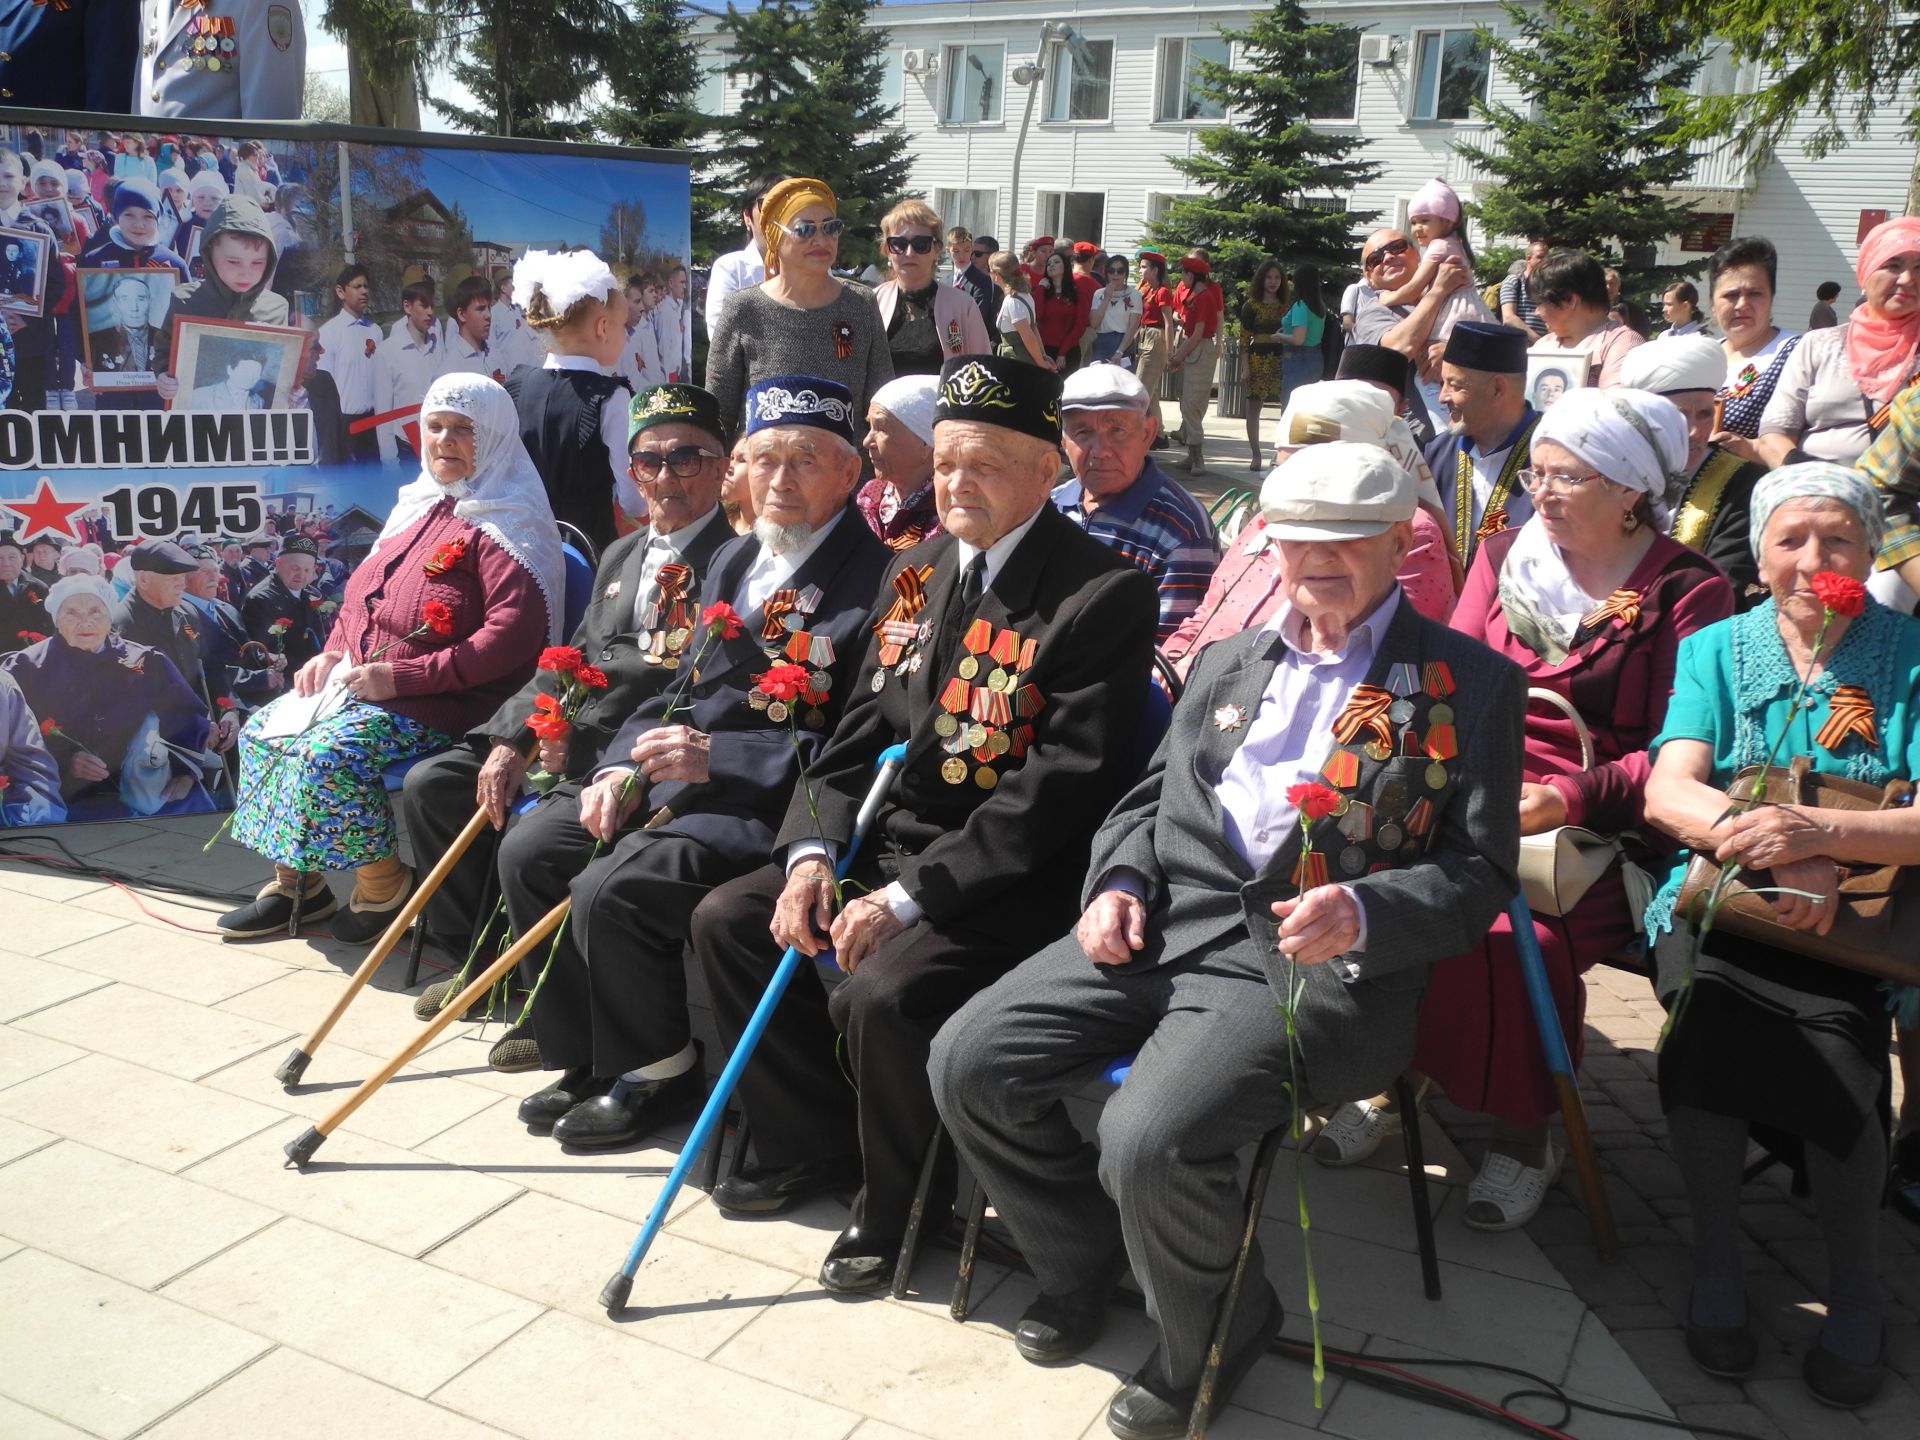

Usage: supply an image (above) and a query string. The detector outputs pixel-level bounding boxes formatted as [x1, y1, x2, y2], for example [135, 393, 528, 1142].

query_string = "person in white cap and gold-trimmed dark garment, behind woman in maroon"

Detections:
[1620, 334, 1766, 611]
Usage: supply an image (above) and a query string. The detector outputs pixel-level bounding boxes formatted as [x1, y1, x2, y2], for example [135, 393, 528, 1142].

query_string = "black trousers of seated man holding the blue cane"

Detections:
[693, 860, 1025, 1236]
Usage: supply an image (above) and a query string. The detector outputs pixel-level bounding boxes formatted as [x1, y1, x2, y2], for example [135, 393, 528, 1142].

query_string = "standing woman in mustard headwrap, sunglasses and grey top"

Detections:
[707, 179, 893, 426]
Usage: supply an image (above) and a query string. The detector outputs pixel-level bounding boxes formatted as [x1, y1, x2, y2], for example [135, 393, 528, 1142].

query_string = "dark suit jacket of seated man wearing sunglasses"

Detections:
[480, 507, 735, 780]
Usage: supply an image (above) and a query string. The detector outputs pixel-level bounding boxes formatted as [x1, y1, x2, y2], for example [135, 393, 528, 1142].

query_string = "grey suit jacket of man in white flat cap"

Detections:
[1083, 597, 1526, 1104]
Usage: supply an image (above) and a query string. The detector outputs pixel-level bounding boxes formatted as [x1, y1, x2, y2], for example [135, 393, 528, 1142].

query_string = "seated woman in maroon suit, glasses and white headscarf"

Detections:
[1315, 388, 1734, 1231]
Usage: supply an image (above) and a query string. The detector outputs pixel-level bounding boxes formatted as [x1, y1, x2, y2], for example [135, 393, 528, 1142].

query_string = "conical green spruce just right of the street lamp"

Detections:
[1150, 0, 1380, 295]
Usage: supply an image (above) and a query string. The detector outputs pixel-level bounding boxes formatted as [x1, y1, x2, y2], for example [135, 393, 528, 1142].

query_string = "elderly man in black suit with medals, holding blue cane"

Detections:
[693, 355, 1158, 1290]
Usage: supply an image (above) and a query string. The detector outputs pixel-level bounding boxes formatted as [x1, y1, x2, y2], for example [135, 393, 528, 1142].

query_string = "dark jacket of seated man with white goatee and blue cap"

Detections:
[607, 503, 893, 870]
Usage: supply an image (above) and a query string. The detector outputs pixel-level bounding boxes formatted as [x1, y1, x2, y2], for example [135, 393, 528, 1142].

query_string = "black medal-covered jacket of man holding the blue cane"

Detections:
[778, 505, 1160, 948]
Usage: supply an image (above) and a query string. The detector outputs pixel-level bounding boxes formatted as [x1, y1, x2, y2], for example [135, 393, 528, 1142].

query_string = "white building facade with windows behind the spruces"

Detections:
[701, 0, 1912, 314]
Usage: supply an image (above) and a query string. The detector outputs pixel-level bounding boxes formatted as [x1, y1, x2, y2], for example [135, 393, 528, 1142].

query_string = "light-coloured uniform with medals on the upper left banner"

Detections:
[135, 0, 307, 119]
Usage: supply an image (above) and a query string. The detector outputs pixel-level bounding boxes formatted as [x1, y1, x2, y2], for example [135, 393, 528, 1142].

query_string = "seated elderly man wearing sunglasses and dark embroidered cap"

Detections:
[399, 384, 733, 975]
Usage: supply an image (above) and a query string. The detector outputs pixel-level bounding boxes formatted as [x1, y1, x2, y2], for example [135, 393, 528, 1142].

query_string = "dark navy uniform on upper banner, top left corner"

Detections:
[0, 0, 140, 115]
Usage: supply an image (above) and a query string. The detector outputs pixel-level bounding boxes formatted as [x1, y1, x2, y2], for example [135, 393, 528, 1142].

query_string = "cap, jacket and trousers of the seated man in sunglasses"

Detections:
[399, 386, 733, 960]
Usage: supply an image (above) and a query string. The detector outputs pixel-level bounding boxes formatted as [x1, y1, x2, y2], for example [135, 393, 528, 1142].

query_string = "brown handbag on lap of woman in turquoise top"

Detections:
[1674, 755, 1920, 985]
